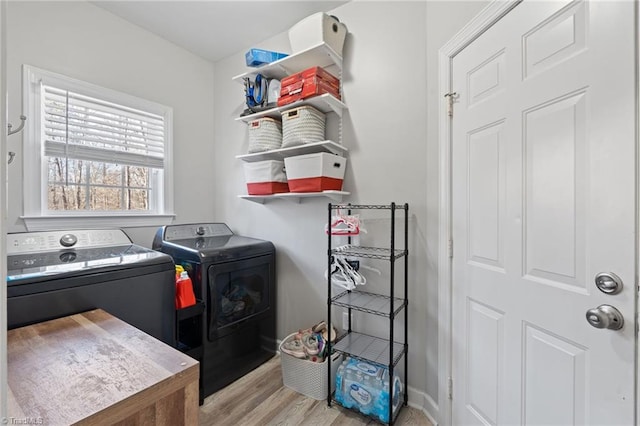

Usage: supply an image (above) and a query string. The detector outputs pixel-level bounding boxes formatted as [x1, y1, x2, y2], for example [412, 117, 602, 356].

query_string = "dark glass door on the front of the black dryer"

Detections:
[207, 255, 275, 340]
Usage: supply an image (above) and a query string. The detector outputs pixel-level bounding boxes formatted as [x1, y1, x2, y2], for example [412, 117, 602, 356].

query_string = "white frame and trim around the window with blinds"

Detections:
[21, 64, 175, 231]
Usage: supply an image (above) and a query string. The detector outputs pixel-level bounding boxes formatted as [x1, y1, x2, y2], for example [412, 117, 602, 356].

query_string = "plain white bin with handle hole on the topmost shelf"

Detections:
[289, 12, 347, 56]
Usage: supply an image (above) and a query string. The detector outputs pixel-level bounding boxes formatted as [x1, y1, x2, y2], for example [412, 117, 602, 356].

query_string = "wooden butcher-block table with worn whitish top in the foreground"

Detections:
[7, 309, 199, 426]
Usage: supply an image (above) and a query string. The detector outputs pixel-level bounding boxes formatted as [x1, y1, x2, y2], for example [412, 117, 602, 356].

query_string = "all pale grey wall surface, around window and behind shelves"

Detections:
[1, 1, 487, 417]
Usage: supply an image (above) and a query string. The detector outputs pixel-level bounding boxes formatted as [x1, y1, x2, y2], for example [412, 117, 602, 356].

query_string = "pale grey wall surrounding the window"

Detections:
[7, 1, 216, 247]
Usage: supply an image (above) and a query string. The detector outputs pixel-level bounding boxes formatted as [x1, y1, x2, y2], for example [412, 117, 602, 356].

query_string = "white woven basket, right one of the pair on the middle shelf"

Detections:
[282, 105, 326, 148]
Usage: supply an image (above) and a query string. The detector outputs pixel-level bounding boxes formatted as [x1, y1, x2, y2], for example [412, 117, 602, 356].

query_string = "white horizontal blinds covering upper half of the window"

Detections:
[42, 85, 166, 169]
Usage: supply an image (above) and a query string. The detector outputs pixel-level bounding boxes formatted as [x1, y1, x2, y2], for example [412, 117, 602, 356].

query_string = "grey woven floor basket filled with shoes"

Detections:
[279, 333, 342, 400]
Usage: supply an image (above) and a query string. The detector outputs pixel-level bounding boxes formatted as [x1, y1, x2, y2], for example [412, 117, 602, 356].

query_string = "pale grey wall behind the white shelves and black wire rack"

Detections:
[214, 1, 485, 416]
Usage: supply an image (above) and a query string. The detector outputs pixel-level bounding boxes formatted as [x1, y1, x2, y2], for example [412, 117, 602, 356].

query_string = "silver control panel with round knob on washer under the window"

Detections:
[7, 229, 131, 255]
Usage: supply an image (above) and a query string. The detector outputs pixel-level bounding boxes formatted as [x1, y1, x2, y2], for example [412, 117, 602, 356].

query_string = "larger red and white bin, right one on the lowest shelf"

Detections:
[284, 152, 347, 192]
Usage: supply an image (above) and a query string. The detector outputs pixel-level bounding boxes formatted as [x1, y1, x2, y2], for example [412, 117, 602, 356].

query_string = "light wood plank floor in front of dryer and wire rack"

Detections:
[200, 356, 431, 426]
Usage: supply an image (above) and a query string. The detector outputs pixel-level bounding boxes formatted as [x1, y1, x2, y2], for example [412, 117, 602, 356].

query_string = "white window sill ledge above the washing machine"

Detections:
[20, 214, 175, 232]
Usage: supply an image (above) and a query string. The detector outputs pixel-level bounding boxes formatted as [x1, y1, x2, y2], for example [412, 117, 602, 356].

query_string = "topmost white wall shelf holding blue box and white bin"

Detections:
[232, 43, 342, 83]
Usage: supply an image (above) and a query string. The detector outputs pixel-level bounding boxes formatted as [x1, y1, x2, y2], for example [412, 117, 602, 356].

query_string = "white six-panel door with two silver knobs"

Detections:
[451, 1, 637, 425]
